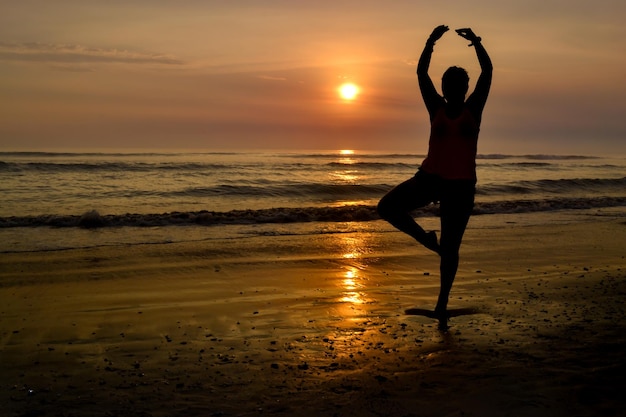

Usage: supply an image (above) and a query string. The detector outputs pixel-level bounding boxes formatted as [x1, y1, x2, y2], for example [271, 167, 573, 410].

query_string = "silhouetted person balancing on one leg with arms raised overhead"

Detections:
[378, 25, 493, 327]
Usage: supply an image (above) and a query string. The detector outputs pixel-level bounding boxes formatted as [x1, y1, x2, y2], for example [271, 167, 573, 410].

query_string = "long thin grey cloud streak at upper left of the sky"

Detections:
[0, 42, 184, 65]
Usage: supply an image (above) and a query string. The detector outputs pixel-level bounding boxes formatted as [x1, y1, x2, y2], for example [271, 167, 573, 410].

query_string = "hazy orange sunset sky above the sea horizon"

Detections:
[0, 0, 626, 154]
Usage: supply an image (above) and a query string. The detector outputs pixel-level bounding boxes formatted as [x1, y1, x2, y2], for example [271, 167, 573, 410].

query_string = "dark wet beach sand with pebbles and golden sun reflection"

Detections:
[0, 216, 626, 417]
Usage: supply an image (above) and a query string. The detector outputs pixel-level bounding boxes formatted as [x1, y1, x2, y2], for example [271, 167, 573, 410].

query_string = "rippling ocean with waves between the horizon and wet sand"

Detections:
[0, 151, 626, 252]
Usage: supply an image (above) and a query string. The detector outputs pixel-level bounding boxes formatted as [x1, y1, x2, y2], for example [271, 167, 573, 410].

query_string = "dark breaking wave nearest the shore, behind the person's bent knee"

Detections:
[0, 197, 626, 228]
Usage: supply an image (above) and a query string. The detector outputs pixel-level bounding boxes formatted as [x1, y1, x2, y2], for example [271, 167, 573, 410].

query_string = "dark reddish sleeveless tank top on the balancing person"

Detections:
[420, 107, 480, 180]
